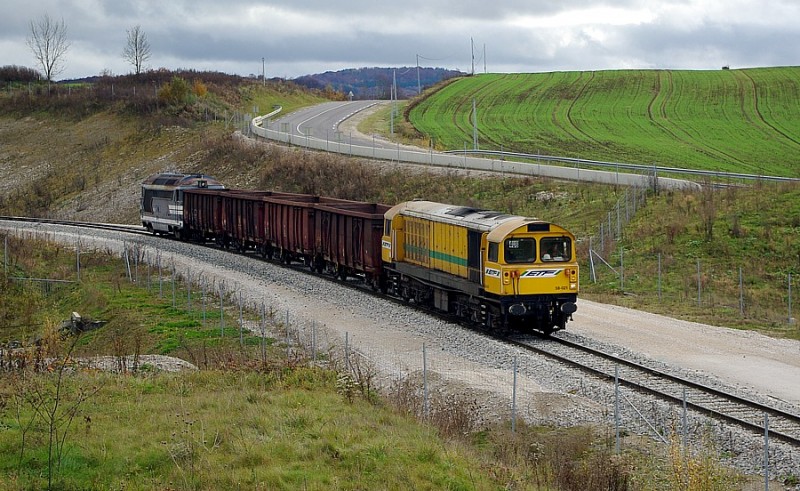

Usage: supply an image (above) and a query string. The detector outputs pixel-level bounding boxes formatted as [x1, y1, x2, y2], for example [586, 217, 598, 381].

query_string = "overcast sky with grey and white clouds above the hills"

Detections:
[0, 0, 800, 80]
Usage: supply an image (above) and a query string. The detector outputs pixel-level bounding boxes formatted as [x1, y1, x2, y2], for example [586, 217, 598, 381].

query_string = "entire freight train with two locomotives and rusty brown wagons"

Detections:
[141, 174, 579, 335]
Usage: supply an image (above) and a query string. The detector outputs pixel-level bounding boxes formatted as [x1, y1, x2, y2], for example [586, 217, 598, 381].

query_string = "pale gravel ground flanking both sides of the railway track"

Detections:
[0, 221, 800, 484]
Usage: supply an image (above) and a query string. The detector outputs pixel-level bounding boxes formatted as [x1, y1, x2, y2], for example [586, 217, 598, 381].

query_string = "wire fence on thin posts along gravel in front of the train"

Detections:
[0, 232, 778, 477]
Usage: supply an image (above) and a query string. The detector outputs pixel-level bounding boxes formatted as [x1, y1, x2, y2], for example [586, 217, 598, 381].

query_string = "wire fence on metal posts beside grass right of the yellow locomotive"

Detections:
[579, 188, 796, 327]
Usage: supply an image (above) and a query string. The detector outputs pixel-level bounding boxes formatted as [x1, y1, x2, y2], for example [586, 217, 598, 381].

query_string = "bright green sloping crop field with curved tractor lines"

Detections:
[409, 67, 800, 177]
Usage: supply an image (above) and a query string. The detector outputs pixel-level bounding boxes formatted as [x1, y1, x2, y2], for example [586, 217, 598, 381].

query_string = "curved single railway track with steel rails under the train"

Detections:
[0, 216, 800, 448]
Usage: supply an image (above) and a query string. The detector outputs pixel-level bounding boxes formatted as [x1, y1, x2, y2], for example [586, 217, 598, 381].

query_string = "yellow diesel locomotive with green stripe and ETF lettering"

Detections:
[382, 201, 579, 334]
